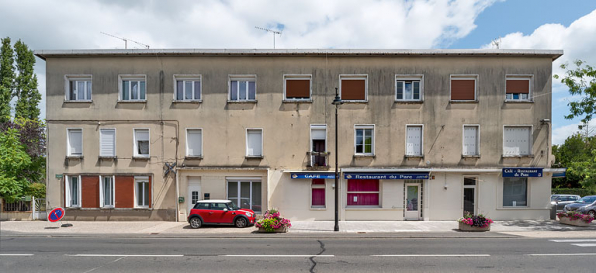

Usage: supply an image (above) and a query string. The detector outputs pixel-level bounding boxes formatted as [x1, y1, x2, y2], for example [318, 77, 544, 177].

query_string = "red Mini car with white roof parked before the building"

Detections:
[187, 200, 255, 228]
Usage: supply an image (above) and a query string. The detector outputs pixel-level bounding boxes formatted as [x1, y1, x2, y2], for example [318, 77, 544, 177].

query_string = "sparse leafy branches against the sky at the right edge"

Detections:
[554, 60, 596, 125]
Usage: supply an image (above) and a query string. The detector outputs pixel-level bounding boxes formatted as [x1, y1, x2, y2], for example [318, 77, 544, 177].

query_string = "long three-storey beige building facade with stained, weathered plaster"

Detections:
[36, 50, 563, 221]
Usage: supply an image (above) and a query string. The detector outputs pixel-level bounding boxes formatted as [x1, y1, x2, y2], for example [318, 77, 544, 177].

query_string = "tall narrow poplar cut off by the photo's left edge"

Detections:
[0, 37, 15, 122]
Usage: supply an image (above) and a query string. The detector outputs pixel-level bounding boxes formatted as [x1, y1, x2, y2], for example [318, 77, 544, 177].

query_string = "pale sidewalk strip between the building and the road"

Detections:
[0, 220, 596, 238]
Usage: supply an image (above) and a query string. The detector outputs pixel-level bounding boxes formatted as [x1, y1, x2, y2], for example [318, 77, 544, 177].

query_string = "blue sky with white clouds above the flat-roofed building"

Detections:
[0, 0, 596, 144]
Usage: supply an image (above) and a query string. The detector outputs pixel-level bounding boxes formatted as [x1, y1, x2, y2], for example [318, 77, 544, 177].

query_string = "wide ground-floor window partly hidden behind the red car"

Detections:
[228, 179, 262, 213]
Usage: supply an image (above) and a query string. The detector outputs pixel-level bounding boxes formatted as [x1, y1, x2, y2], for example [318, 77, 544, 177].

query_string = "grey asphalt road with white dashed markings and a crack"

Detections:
[0, 236, 596, 273]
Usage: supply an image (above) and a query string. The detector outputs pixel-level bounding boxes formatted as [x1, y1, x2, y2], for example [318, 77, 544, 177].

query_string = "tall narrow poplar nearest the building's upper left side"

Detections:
[14, 40, 41, 120]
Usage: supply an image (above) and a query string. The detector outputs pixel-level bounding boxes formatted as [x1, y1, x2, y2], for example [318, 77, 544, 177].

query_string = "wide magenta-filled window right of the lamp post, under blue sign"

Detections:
[348, 179, 379, 206]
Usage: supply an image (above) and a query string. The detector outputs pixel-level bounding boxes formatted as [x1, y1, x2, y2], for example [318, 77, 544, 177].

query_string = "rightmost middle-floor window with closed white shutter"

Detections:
[503, 126, 532, 156]
